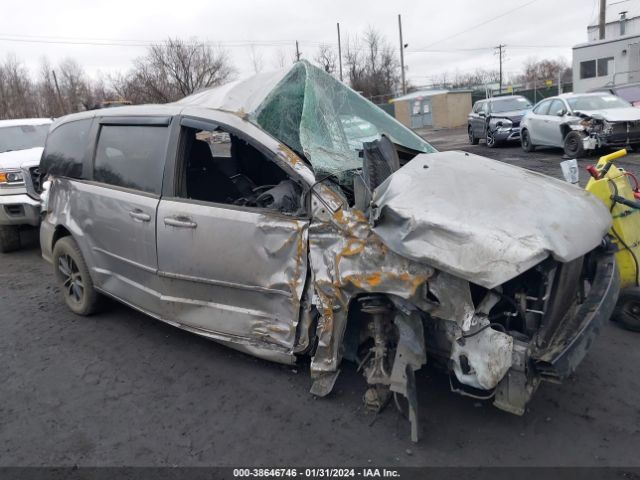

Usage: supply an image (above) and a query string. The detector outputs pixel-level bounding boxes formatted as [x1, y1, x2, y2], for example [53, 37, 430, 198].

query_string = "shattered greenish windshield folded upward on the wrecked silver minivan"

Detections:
[252, 61, 436, 180]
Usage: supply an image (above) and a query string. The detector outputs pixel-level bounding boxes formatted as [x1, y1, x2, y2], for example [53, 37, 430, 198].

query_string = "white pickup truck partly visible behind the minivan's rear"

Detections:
[0, 118, 51, 252]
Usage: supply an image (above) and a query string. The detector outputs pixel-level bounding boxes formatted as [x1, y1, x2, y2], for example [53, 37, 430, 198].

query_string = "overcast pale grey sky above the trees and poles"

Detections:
[0, 0, 608, 85]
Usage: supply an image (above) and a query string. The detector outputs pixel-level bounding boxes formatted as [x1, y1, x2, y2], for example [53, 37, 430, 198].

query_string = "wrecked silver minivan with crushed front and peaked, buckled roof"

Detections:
[41, 61, 618, 440]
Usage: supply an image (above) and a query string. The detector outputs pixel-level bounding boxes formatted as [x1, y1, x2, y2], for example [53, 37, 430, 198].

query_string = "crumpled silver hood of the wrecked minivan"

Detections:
[373, 151, 611, 288]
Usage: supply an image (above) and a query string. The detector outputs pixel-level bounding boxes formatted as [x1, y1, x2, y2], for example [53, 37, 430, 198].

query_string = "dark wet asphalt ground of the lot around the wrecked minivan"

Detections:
[0, 125, 640, 466]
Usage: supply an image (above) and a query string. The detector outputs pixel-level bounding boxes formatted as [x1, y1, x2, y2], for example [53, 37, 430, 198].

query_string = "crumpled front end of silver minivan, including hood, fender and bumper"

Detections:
[309, 152, 618, 440]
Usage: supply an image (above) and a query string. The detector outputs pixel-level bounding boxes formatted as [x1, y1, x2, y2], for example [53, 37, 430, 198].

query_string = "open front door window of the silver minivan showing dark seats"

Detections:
[176, 126, 302, 213]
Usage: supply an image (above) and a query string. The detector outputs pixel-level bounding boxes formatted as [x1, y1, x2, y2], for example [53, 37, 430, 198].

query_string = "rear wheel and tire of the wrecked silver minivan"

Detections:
[53, 237, 101, 315]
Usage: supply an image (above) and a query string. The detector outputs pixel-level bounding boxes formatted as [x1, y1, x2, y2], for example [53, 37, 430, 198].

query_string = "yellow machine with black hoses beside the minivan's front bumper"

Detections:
[586, 150, 640, 331]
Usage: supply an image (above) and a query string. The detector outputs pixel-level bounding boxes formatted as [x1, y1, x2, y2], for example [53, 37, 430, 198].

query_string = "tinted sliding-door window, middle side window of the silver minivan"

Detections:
[93, 125, 169, 194]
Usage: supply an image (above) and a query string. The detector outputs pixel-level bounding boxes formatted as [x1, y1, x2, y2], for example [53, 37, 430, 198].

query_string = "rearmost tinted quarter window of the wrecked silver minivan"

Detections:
[40, 118, 92, 178]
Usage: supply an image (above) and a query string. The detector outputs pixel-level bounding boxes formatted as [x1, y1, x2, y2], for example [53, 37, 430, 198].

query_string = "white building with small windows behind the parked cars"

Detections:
[573, 0, 640, 92]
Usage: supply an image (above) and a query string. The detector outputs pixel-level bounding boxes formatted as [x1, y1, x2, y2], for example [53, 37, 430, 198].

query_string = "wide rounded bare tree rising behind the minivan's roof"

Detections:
[112, 39, 234, 103]
